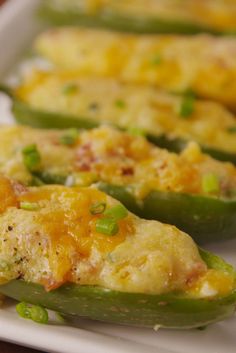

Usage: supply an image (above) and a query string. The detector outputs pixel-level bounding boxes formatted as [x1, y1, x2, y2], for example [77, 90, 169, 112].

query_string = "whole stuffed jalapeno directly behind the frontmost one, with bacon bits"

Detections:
[0, 126, 236, 243]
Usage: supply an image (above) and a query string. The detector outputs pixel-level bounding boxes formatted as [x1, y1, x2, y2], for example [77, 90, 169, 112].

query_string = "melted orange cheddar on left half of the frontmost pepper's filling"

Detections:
[0, 177, 134, 289]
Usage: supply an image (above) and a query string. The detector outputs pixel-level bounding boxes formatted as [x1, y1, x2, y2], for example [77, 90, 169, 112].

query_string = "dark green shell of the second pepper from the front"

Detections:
[98, 183, 236, 244]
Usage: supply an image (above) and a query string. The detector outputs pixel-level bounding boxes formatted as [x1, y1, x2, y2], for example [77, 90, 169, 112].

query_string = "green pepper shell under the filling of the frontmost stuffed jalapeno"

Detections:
[0, 249, 236, 329]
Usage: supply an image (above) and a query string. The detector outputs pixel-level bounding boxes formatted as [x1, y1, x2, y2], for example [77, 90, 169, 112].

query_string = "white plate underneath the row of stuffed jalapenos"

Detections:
[0, 0, 236, 353]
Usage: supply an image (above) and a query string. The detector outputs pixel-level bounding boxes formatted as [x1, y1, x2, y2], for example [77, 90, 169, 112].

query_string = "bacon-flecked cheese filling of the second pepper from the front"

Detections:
[0, 126, 236, 199]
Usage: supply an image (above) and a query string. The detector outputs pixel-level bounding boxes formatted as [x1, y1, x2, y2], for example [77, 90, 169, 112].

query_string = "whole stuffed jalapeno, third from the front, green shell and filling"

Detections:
[11, 70, 236, 164]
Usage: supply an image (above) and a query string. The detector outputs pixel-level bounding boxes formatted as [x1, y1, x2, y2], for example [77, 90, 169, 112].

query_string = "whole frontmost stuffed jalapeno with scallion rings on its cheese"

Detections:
[0, 177, 236, 328]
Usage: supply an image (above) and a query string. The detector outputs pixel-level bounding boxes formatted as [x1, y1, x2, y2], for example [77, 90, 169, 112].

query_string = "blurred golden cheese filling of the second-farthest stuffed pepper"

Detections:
[35, 28, 236, 109]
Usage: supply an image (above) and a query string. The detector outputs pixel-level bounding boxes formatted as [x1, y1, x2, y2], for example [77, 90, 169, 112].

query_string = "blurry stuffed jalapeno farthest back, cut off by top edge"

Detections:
[40, 0, 236, 34]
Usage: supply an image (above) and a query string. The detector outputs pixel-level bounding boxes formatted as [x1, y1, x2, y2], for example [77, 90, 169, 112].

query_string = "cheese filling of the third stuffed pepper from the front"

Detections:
[16, 70, 236, 153]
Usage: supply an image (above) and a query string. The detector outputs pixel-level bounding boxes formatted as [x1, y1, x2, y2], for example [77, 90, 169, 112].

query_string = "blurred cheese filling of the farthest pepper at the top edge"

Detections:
[47, 0, 236, 31]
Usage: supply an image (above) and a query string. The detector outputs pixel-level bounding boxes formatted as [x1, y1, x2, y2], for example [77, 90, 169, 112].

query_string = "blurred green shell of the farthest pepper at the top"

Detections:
[38, 1, 221, 34]
